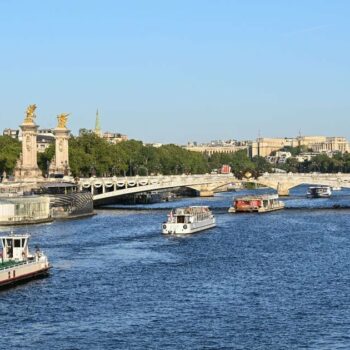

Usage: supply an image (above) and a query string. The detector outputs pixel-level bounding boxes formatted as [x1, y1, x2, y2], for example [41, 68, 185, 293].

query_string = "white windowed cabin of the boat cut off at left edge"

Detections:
[0, 235, 30, 262]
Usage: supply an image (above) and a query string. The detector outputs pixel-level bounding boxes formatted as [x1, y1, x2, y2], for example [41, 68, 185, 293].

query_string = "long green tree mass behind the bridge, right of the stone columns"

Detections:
[62, 134, 271, 177]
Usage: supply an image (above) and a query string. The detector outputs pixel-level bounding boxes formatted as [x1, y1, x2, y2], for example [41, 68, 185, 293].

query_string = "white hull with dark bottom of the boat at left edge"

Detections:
[0, 261, 51, 289]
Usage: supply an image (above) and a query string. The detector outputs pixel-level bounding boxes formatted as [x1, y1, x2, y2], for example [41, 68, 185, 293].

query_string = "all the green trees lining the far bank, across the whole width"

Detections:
[0, 134, 350, 178]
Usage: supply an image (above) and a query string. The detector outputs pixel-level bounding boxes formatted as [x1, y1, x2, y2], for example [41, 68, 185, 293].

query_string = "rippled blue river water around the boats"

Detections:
[0, 188, 350, 349]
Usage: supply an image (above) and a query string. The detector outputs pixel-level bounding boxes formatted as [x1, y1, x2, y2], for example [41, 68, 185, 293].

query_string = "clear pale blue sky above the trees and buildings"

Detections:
[0, 0, 350, 144]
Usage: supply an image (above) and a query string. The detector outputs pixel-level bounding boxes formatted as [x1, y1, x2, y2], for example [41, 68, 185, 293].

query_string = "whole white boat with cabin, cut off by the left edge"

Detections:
[0, 233, 51, 288]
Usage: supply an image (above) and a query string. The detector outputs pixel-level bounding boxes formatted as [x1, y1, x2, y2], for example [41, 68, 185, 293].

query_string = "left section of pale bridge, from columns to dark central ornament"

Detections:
[78, 174, 239, 206]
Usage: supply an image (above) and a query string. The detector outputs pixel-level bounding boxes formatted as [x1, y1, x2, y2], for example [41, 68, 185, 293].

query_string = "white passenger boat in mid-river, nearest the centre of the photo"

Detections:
[162, 206, 216, 235]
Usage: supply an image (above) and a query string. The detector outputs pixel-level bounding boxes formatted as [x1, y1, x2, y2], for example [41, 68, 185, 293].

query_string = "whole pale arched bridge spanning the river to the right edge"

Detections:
[78, 173, 350, 206]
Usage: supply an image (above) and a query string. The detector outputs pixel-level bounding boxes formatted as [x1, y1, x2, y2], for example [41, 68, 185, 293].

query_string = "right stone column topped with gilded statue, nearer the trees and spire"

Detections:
[50, 114, 70, 176]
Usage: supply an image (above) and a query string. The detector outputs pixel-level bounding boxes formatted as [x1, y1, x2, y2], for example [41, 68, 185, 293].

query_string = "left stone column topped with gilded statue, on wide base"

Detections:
[15, 105, 42, 181]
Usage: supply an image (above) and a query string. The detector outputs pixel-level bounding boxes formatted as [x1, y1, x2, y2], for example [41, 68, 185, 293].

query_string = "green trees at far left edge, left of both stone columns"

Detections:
[0, 136, 21, 175]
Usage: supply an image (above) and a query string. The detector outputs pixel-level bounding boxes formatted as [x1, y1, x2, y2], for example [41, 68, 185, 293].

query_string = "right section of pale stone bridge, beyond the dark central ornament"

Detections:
[254, 173, 350, 196]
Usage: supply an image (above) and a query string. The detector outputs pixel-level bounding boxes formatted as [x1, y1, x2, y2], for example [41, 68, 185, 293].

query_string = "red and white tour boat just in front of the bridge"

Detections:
[228, 194, 284, 213]
